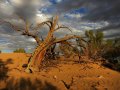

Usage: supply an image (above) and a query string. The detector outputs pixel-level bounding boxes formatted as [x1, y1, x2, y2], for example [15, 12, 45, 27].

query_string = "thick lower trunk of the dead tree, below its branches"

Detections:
[26, 40, 53, 73]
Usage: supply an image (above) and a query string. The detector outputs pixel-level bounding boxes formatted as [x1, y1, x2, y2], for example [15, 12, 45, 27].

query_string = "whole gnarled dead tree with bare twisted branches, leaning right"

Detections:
[1, 16, 82, 72]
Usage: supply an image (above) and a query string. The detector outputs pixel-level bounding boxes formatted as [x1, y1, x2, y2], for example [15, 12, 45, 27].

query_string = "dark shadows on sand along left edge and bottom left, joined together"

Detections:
[0, 59, 57, 90]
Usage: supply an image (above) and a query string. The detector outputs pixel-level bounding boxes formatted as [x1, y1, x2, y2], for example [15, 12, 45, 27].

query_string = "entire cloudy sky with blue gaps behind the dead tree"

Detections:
[0, 0, 120, 52]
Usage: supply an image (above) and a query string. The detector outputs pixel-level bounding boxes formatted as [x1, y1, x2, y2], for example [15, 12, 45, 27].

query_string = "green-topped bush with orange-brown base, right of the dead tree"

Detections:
[76, 30, 104, 60]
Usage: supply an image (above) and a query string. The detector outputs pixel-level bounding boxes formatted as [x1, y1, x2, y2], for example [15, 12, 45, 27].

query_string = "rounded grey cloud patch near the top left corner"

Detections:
[9, 0, 37, 21]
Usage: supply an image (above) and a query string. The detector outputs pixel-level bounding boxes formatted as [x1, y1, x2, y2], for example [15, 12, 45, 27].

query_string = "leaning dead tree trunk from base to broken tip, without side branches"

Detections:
[26, 17, 58, 72]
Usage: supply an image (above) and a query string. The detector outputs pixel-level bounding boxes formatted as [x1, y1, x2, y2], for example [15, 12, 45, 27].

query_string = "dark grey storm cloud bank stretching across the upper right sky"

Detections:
[52, 0, 120, 36]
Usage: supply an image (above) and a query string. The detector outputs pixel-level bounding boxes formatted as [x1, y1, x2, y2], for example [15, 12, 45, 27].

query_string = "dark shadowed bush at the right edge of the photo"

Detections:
[103, 38, 120, 71]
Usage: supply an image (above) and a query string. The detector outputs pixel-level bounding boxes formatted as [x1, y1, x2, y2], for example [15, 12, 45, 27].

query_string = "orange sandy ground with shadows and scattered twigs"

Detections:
[0, 53, 120, 90]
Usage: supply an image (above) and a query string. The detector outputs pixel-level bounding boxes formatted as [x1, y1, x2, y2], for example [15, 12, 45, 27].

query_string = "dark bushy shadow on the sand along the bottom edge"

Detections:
[3, 78, 57, 90]
